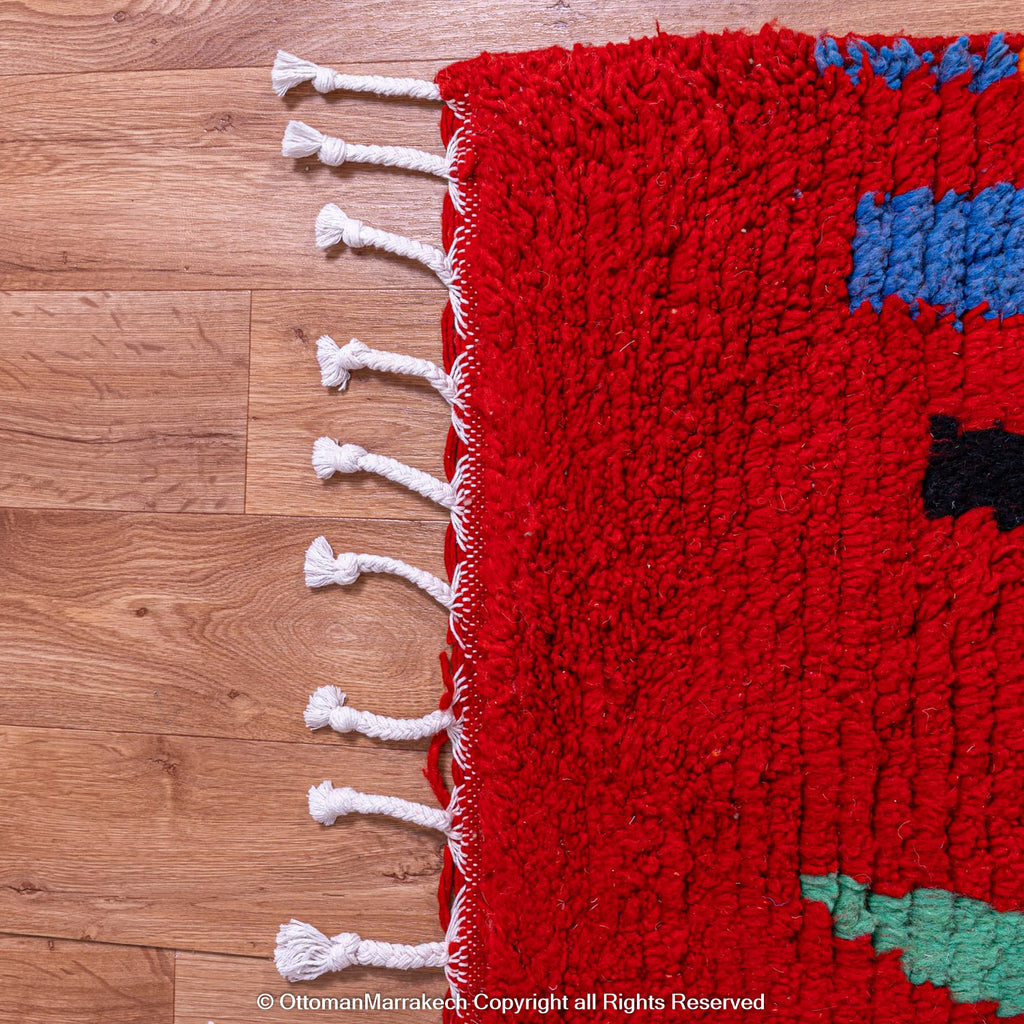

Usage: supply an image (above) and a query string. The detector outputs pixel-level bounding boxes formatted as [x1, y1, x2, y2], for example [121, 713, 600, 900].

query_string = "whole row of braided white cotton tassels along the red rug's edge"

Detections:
[272, 51, 475, 995]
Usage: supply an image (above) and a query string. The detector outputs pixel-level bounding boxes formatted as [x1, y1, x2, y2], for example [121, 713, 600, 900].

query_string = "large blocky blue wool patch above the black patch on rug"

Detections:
[849, 184, 1024, 327]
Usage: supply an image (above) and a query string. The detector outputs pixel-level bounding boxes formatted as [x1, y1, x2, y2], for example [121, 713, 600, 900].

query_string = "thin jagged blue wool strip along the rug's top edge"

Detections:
[814, 32, 1018, 92]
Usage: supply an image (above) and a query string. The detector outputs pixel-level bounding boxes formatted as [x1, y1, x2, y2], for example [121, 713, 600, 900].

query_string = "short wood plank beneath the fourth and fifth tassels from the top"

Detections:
[246, 289, 451, 520]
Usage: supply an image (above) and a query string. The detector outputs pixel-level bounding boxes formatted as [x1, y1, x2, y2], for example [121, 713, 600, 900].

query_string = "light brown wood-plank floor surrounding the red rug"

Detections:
[0, 0, 1024, 1024]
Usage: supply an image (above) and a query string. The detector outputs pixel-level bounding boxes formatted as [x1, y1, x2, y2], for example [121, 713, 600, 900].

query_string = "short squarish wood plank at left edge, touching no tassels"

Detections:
[0, 292, 249, 512]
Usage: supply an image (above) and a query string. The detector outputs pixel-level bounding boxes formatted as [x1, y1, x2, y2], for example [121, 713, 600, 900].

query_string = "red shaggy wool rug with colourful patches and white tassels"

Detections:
[275, 28, 1024, 1024]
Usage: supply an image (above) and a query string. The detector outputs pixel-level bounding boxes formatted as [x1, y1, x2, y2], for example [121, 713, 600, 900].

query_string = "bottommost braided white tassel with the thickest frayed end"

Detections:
[273, 918, 449, 982]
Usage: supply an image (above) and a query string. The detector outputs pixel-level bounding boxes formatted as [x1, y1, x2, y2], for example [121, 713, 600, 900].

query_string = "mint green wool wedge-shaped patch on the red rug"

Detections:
[800, 873, 1024, 1017]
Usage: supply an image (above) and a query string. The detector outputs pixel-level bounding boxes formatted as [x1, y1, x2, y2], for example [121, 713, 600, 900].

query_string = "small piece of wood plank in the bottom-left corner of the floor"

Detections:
[0, 935, 172, 1024]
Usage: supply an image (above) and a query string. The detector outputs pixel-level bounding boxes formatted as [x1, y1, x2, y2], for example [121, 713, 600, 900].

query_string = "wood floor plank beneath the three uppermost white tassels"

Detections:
[0, 67, 443, 291]
